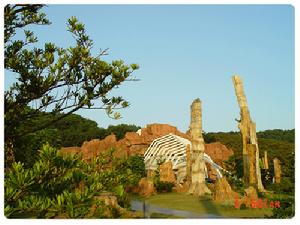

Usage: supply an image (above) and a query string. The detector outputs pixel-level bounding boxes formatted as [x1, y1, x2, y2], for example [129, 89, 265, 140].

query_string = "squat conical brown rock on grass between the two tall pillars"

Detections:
[213, 177, 238, 205]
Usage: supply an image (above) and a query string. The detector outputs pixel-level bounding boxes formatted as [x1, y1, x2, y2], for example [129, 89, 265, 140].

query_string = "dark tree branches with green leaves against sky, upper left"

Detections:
[4, 5, 138, 167]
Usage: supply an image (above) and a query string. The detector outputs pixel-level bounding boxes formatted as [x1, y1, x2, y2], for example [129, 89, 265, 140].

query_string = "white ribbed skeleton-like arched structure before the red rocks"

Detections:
[144, 133, 229, 182]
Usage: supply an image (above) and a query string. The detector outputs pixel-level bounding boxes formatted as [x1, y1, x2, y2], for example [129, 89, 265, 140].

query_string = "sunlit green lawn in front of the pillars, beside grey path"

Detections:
[134, 193, 272, 218]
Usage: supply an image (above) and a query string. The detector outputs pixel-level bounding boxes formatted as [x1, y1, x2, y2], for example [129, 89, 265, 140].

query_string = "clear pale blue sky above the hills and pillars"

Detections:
[5, 5, 295, 132]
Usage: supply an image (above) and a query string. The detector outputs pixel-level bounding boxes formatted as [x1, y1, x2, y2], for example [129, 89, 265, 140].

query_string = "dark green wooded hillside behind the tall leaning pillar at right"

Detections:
[204, 129, 295, 194]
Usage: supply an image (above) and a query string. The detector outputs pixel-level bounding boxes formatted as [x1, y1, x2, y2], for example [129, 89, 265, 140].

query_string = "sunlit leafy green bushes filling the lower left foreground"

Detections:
[5, 145, 142, 218]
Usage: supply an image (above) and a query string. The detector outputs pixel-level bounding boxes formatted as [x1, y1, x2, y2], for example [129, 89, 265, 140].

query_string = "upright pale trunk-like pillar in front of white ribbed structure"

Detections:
[189, 98, 211, 196]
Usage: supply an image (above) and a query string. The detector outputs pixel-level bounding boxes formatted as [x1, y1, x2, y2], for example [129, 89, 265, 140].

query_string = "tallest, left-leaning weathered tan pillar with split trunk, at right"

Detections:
[232, 76, 264, 191]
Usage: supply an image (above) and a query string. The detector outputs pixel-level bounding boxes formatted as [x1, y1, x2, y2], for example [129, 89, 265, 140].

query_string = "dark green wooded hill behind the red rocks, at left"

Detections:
[15, 113, 140, 166]
